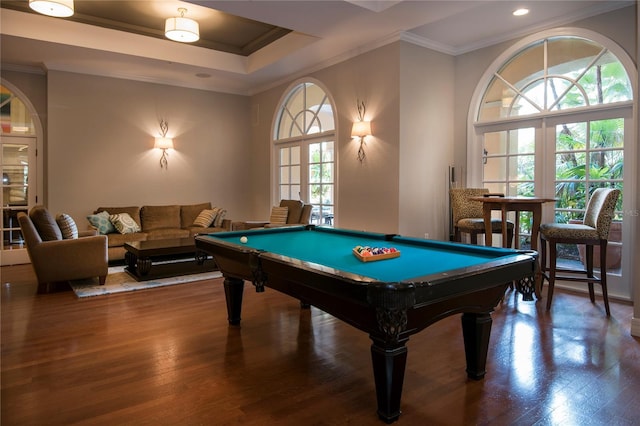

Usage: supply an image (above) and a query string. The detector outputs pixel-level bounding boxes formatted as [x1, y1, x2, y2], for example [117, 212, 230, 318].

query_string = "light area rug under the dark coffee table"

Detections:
[70, 266, 222, 298]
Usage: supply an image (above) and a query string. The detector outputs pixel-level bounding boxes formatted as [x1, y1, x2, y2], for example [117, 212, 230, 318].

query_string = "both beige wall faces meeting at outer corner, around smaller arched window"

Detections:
[252, 42, 454, 239]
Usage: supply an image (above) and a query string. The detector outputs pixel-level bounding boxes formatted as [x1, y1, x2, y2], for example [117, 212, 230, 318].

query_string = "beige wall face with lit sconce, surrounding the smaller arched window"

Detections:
[251, 43, 400, 233]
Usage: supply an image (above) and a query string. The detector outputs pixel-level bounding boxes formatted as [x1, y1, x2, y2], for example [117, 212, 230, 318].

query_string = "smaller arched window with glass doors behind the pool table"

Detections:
[273, 81, 336, 225]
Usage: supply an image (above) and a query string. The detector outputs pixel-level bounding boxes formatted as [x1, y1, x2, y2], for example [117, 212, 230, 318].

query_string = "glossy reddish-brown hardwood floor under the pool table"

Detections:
[1, 265, 640, 426]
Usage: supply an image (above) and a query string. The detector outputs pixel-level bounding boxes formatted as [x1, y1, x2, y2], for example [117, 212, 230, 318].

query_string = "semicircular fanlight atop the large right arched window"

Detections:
[478, 37, 633, 122]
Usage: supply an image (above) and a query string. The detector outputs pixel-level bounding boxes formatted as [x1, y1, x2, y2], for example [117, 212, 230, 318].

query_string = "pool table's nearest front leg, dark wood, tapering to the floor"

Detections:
[370, 336, 407, 423]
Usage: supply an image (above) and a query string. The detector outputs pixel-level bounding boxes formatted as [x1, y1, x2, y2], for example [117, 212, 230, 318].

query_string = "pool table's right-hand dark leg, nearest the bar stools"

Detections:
[462, 313, 492, 380]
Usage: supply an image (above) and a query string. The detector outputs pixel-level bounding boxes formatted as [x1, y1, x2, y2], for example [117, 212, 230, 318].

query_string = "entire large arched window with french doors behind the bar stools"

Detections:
[468, 29, 637, 297]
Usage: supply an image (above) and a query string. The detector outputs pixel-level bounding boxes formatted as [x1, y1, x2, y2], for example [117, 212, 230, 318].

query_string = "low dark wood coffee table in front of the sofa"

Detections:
[124, 237, 218, 281]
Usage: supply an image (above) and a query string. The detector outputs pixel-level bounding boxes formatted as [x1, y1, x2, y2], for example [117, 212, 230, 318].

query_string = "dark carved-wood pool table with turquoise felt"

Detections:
[195, 225, 536, 423]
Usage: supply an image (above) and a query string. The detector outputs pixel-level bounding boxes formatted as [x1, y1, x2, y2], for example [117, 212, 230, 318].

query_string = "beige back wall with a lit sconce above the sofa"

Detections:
[46, 71, 249, 228]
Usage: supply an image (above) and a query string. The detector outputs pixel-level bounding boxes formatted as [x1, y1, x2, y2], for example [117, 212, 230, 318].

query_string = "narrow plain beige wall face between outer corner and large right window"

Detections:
[399, 43, 455, 240]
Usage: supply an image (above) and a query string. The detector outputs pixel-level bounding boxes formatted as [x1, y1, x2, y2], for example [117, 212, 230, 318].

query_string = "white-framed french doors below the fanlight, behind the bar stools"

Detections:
[476, 108, 634, 297]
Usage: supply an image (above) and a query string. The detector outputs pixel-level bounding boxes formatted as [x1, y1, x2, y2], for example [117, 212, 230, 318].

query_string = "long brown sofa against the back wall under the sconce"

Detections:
[90, 203, 231, 262]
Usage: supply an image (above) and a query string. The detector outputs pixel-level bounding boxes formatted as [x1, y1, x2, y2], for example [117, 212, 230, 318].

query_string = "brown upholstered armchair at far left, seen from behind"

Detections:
[18, 206, 108, 293]
